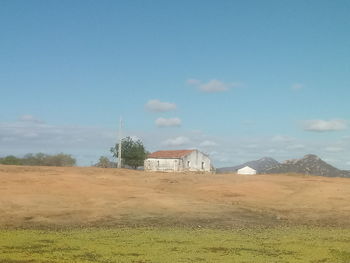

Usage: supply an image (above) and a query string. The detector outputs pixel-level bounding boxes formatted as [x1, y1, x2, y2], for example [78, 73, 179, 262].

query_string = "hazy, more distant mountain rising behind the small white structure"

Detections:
[216, 157, 280, 173]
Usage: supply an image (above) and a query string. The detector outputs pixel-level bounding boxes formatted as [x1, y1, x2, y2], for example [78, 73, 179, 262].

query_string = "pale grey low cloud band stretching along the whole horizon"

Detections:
[0, 117, 350, 169]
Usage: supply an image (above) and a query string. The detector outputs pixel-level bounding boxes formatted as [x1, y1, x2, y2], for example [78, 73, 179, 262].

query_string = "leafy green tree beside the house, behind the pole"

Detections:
[111, 137, 147, 169]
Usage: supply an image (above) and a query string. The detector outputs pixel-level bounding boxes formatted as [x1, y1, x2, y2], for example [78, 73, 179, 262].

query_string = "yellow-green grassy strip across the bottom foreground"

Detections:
[0, 227, 350, 263]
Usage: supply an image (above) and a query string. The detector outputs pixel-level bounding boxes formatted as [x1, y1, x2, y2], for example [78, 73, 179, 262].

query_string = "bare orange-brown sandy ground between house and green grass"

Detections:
[0, 165, 350, 227]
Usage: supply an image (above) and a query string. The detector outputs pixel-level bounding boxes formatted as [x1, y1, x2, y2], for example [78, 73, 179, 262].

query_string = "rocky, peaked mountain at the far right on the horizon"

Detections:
[265, 154, 350, 177]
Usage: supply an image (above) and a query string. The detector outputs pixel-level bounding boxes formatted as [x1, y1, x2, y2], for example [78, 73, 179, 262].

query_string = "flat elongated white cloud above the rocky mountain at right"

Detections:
[303, 119, 347, 132]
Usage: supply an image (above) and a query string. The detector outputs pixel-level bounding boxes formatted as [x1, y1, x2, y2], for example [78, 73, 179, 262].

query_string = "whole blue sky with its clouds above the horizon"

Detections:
[0, 0, 350, 169]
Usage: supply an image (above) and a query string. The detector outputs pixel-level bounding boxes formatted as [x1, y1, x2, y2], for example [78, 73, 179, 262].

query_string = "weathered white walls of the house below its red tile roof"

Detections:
[144, 151, 211, 172]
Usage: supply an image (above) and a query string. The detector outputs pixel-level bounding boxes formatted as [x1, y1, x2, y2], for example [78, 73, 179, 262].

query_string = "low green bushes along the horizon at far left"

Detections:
[0, 153, 76, 166]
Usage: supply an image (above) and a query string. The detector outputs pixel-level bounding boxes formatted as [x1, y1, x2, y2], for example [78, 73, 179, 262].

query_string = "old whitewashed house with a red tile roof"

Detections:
[144, 150, 212, 172]
